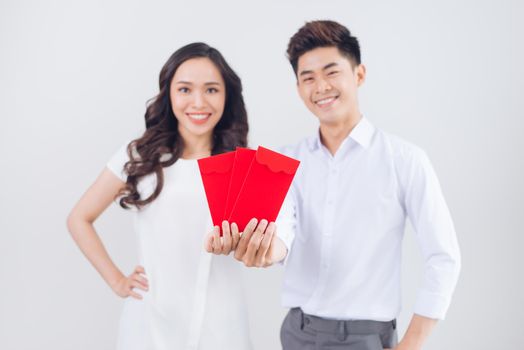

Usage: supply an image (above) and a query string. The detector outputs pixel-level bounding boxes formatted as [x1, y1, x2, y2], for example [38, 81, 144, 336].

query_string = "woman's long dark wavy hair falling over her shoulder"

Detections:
[119, 43, 248, 209]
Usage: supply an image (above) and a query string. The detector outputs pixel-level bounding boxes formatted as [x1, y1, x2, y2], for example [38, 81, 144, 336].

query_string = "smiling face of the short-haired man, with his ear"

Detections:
[297, 47, 366, 126]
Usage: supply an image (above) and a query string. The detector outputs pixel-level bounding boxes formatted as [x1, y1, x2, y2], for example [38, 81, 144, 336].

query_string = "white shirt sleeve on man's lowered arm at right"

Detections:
[400, 149, 461, 319]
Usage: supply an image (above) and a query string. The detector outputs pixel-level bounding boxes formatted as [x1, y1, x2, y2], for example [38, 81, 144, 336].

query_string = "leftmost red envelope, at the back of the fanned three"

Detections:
[198, 152, 235, 227]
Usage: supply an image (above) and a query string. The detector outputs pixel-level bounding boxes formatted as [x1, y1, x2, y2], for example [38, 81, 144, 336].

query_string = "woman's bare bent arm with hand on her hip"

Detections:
[67, 168, 148, 299]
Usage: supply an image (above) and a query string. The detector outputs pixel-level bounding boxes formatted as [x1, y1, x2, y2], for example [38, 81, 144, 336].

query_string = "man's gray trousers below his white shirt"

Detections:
[280, 308, 397, 350]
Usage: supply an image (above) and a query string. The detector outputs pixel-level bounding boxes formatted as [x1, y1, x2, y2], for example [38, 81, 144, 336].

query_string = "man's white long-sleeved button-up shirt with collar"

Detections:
[277, 118, 460, 321]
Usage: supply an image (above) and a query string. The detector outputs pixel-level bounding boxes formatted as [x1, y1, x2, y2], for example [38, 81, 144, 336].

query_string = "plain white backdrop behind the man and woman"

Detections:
[0, 0, 524, 350]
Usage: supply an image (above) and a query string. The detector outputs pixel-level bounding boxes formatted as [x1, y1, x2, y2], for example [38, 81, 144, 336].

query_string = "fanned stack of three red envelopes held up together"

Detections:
[198, 147, 300, 231]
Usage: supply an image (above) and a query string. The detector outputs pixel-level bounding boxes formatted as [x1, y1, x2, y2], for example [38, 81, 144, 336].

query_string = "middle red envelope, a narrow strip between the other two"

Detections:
[224, 147, 256, 218]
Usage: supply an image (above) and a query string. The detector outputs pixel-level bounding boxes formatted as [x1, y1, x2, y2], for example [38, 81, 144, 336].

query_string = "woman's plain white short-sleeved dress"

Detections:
[107, 144, 252, 350]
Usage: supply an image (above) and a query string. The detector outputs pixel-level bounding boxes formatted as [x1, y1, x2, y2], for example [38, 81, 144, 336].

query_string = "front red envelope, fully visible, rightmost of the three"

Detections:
[229, 147, 300, 231]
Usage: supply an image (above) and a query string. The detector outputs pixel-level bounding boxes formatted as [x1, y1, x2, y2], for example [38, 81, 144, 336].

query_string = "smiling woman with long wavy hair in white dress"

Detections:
[68, 43, 251, 350]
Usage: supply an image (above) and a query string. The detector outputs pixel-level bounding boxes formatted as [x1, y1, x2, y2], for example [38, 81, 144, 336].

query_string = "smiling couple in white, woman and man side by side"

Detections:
[68, 21, 460, 350]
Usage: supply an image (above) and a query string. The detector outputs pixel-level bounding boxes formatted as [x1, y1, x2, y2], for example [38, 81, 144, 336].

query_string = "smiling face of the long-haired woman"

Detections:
[170, 57, 226, 142]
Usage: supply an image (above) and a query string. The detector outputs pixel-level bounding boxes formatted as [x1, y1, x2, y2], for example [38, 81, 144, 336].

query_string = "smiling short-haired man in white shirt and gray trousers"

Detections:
[208, 21, 460, 350]
